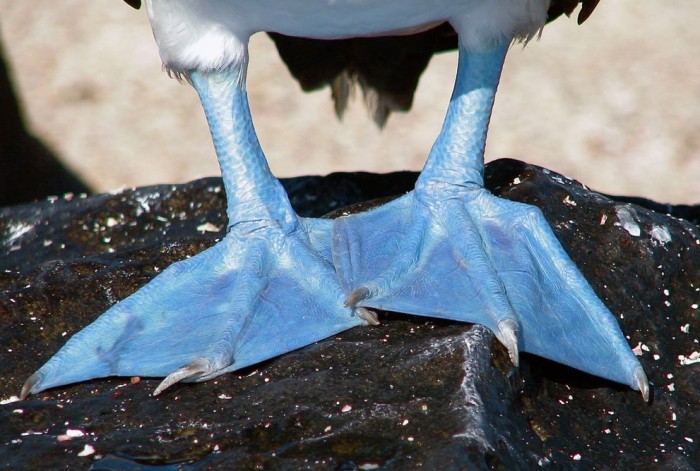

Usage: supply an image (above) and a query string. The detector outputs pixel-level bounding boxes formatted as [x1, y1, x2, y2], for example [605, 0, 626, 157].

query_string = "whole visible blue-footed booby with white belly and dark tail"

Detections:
[21, 0, 649, 399]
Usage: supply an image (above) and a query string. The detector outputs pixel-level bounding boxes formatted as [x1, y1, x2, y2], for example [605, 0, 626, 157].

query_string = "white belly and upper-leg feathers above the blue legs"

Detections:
[146, 0, 550, 72]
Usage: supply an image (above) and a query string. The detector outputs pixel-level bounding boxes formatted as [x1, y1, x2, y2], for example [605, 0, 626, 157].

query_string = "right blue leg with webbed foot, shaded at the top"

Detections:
[333, 45, 648, 397]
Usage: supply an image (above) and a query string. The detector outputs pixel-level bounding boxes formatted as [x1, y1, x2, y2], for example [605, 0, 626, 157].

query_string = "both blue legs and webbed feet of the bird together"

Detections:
[21, 45, 648, 399]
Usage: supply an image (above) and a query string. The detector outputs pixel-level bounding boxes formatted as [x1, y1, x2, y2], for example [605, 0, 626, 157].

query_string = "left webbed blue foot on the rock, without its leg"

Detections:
[22, 221, 372, 397]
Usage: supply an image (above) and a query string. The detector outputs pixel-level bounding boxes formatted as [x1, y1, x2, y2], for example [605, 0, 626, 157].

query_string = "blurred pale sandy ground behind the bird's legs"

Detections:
[0, 0, 700, 203]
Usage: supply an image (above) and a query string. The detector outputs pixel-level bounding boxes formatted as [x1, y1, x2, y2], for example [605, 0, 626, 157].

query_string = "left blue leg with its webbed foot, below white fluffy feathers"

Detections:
[22, 63, 376, 397]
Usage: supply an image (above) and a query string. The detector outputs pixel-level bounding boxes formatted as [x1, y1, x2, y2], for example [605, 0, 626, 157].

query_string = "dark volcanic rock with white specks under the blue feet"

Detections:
[0, 161, 700, 470]
